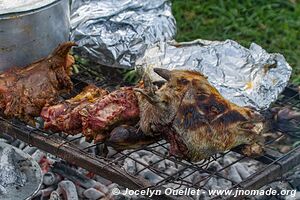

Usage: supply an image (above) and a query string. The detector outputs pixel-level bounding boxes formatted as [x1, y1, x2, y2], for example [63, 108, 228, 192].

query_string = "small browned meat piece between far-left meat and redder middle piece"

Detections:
[41, 85, 108, 134]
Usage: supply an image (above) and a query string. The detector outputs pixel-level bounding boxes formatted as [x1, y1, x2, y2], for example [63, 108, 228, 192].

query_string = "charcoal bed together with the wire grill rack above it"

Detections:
[0, 63, 300, 199]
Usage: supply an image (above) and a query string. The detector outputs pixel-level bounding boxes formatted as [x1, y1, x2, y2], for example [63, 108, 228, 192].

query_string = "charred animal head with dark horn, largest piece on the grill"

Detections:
[136, 69, 264, 161]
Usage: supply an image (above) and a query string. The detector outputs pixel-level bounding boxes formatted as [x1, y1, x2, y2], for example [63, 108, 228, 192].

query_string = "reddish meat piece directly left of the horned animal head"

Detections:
[79, 87, 139, 142]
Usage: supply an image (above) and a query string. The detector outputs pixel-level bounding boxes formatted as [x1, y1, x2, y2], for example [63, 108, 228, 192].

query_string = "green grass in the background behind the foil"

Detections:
[172, 0, 300, 84]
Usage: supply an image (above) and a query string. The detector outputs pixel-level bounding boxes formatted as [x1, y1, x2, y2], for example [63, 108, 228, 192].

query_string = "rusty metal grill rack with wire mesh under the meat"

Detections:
[0, 66, 300, 199]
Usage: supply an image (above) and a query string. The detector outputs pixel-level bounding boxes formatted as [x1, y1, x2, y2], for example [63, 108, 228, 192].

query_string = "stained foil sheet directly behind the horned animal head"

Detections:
[136, 40, 292, 110]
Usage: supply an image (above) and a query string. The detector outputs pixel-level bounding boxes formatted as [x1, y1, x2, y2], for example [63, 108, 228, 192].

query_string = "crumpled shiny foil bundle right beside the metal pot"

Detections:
[71, 0, 176, 68]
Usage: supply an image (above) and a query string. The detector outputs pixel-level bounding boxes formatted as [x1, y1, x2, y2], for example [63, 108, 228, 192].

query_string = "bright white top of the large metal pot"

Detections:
[0, 0, 59, 15]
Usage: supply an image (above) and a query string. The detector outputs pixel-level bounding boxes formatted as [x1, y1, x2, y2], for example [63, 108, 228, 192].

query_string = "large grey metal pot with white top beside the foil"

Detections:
[0, 0, 70, 71]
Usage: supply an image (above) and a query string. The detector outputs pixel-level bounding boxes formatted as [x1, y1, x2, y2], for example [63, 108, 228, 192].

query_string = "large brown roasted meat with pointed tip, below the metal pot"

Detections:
[0, 42, 75, 124]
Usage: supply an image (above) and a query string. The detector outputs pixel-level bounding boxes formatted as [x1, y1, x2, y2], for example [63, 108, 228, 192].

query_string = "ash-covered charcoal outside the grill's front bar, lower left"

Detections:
[2, 139, 118, 200]
